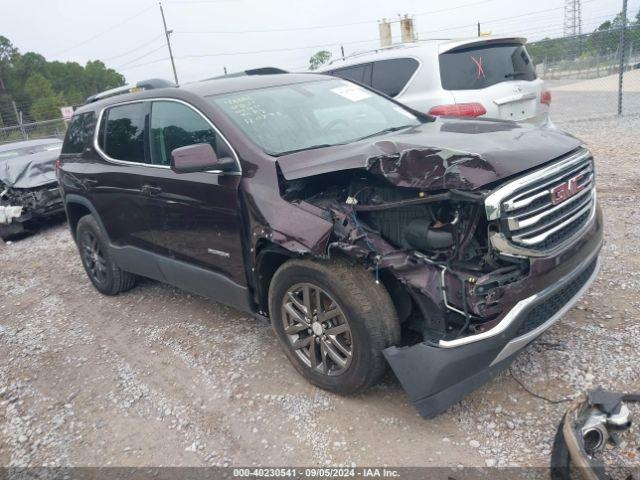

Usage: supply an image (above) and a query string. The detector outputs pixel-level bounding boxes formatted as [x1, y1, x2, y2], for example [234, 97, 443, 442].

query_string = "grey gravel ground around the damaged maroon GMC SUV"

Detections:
[0, 118, 640, 467]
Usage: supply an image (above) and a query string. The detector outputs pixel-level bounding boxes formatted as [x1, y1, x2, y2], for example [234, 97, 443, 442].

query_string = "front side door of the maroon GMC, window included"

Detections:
[142, 99, 246, 285]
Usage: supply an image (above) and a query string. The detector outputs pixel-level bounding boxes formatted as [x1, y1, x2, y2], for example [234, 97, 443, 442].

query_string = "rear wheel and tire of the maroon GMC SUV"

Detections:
[76, 215, 136, 295]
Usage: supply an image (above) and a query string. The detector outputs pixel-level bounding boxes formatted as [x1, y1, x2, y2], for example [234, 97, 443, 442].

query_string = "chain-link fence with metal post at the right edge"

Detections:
[528, 23, 640, 122]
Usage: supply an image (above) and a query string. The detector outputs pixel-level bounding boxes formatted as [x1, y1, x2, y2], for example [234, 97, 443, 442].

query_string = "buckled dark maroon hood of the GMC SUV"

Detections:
[278, 118, 582, 190]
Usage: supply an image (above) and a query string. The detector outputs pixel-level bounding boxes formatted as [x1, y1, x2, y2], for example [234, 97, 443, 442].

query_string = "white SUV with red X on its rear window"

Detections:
[320, 37, 551, 125]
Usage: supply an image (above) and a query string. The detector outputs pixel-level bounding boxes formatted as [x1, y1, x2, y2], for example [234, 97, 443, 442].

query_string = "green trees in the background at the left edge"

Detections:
[0, 36, 124, 125]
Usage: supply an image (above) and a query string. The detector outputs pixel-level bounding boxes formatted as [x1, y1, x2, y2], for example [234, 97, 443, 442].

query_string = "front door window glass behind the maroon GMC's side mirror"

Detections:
[151, 101, 231, 165]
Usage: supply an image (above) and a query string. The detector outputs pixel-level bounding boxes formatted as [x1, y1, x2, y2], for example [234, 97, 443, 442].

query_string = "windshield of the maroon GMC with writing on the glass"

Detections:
[211, 79, 419, 156]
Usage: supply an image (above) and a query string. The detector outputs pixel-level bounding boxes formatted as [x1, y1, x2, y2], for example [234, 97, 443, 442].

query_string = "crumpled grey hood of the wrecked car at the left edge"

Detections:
[0, 149, 60, 188]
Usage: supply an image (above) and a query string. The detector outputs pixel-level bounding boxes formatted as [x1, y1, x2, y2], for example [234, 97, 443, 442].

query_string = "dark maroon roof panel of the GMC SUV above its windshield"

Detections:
[180, 73, 333, 97]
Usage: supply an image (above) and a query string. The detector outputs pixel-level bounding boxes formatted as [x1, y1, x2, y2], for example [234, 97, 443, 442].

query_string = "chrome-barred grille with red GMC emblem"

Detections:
[487, 149, 595, 255]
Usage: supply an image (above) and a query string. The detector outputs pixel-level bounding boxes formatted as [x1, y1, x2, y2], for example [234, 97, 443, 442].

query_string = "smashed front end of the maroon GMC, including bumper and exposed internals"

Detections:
[281, 141, 602, 417]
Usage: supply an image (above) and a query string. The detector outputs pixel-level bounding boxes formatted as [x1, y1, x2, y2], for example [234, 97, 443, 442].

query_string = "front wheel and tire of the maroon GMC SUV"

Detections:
[269, 259, 400, 394]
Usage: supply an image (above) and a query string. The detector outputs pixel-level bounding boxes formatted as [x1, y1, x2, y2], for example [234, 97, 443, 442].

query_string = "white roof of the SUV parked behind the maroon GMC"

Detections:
[320, 36, 527, 72]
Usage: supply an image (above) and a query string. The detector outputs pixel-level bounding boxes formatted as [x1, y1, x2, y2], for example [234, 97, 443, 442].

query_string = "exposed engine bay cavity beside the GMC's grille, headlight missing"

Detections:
[281, 170, 529, 345]
